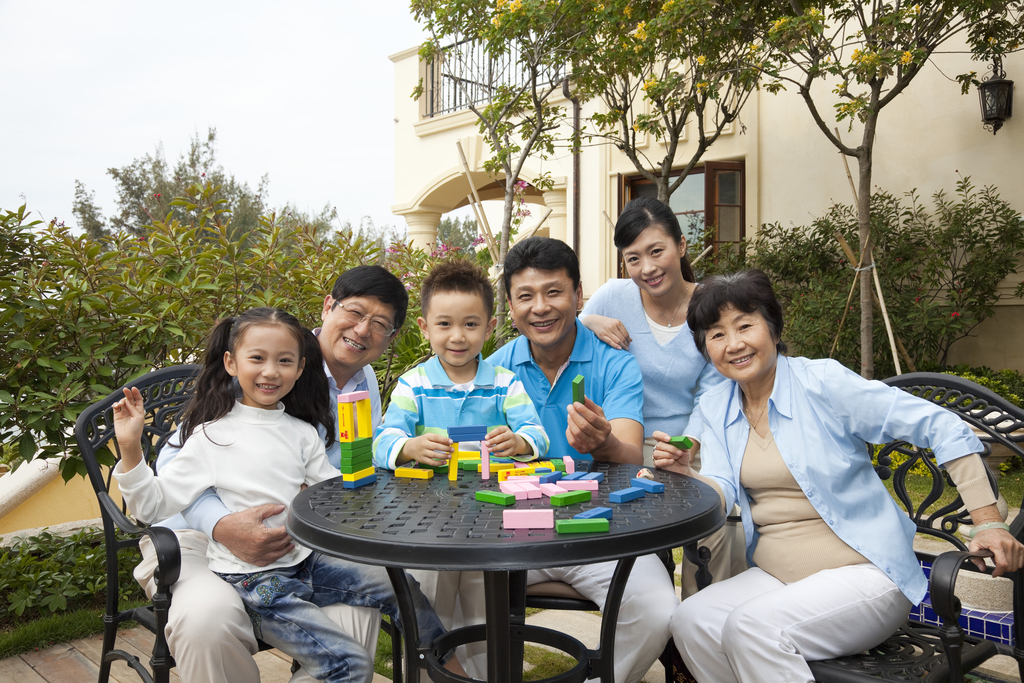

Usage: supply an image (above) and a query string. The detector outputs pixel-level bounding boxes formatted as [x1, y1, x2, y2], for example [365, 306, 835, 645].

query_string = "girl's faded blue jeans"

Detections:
[220, 552, 444, 683]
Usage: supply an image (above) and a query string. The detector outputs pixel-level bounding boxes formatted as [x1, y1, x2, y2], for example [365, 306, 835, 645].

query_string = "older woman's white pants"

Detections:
[671, 564, 910, 683]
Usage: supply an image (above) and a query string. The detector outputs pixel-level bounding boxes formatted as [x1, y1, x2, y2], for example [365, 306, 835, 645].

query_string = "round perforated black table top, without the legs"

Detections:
[287, 462, 724, 570]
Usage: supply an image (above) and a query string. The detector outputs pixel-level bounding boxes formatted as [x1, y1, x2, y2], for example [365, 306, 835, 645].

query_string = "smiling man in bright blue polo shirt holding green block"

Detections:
[487, 238, 679, 683]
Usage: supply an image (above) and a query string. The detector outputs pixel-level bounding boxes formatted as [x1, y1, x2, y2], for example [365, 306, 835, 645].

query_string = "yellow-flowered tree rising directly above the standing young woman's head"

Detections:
[572, 0, 776, 204]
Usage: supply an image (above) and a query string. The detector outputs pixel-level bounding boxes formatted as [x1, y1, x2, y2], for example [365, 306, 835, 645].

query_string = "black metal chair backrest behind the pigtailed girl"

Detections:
[75, 366, 202, 505]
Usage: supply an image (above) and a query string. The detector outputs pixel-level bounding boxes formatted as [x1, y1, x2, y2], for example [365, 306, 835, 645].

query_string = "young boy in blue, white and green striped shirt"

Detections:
[373, 259, 548, 470]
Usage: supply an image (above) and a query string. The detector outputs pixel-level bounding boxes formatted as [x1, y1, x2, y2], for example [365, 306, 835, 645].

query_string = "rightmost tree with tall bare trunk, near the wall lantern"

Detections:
[767, 0, 1024, 378]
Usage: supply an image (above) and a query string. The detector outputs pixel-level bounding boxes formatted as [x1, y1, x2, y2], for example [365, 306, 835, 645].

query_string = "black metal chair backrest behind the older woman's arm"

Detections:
[879, 373, 1024, 550]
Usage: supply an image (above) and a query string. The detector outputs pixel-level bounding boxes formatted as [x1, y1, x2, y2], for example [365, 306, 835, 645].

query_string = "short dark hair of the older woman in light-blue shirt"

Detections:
[686, 270, 786, 360]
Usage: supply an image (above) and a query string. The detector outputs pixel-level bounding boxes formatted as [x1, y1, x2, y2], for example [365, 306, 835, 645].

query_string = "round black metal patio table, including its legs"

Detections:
[287, 461, 725, 683]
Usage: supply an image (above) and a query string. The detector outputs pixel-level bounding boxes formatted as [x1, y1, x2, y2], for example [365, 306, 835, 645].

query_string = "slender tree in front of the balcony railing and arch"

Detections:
[412, 0, 587, 323]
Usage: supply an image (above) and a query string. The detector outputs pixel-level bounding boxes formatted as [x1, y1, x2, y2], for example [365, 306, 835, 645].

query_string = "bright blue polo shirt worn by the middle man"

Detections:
[487, 319, 643, 460]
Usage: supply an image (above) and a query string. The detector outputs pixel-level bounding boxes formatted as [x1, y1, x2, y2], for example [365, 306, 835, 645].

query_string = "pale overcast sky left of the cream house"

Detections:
[0, 0, 424, 229]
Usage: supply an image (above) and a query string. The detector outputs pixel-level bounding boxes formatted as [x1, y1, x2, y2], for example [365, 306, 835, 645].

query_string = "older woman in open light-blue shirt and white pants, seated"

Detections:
[655, 271, 1024, 683]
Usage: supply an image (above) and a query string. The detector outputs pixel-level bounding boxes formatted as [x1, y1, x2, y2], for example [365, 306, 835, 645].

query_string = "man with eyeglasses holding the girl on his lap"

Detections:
[134, 265, 409, 683]
